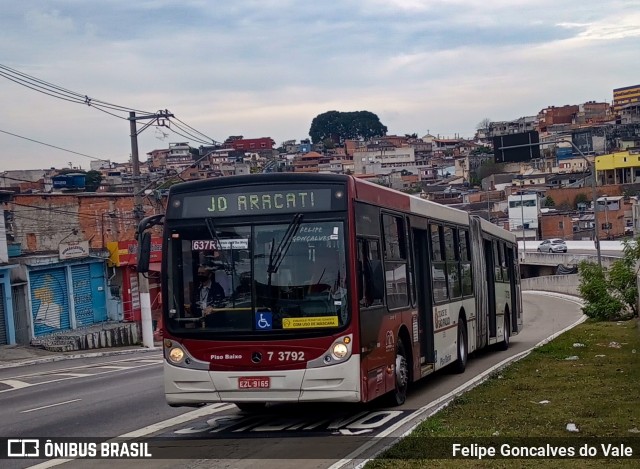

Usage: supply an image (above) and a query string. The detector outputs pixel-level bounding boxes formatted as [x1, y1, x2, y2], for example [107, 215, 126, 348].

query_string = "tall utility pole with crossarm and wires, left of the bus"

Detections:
[129, 110, 173, 348]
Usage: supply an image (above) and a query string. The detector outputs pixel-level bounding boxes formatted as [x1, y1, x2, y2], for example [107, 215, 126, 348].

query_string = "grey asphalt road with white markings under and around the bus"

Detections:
[0, 292, 581, 469]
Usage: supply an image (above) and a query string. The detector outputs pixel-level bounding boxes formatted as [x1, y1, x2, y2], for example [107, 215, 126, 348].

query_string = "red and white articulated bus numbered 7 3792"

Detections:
[139, 173, 522, 411]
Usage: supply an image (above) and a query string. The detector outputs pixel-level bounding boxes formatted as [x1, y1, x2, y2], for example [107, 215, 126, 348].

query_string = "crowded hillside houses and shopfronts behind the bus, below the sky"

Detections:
[0, 85, 640, 346]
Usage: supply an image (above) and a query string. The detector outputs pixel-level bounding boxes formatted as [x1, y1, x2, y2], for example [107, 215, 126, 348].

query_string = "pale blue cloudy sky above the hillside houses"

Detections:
[0, 0, 640, 171]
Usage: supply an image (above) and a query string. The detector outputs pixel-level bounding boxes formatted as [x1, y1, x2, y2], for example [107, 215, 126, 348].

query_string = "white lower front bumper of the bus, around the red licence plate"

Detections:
[164, 355, 361, 406]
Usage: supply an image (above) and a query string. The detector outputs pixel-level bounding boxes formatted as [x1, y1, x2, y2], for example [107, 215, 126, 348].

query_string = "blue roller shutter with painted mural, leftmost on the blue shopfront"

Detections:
[29, 267, 71, 336]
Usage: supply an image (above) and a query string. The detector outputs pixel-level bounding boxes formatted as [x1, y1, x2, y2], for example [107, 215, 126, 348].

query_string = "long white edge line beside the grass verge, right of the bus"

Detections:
[327, 295, 587, 469]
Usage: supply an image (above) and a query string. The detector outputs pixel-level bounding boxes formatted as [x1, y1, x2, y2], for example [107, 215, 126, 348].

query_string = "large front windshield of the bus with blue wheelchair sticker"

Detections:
[162, 215, 349, 336]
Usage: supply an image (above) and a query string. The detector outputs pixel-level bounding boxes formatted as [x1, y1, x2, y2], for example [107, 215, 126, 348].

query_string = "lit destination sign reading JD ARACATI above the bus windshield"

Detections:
[182, 188, 332, 218]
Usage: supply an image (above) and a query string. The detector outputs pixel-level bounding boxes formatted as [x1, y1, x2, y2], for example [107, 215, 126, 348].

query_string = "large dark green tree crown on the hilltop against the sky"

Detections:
[309, 111, 387, 145]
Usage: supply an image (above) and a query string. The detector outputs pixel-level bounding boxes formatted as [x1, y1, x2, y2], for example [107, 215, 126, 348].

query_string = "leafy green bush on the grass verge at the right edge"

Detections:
[579, 238, 640, 320]
